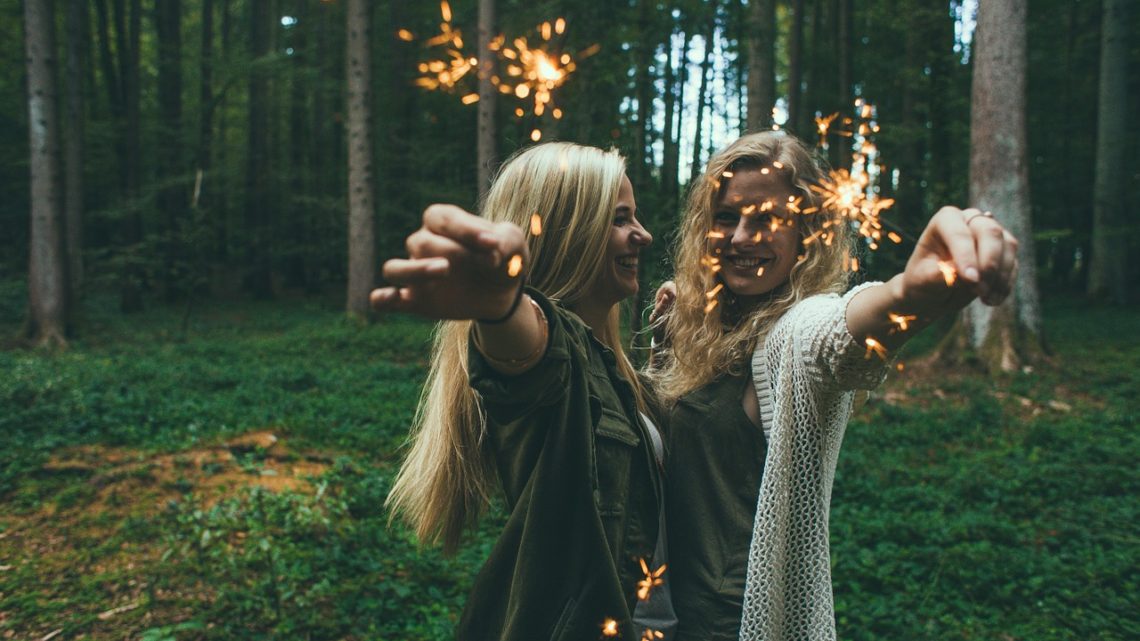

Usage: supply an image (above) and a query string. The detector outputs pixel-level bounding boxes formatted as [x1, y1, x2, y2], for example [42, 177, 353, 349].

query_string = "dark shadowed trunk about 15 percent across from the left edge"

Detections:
[154, 0, 186, 300]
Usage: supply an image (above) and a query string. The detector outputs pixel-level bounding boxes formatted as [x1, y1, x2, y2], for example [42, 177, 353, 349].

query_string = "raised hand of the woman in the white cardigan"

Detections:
[899, 206, 1018, 313]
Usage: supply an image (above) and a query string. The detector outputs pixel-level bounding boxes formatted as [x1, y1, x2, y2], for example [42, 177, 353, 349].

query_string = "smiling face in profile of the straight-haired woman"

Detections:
[584, 172, 653, 306]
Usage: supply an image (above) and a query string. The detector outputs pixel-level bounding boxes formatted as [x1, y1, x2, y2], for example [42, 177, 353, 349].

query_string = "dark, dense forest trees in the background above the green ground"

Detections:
[0, 0, 1140, 339]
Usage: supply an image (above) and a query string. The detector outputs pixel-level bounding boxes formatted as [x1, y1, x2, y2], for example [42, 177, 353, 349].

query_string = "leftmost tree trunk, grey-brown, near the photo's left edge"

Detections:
[24, 0, 67, 347]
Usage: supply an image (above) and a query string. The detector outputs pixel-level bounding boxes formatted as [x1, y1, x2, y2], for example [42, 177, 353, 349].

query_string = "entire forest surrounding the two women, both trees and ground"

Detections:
[0, 0, 1140, 641]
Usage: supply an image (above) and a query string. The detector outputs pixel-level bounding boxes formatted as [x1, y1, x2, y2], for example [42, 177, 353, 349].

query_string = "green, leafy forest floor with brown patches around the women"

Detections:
[0, 287, 1140, 641]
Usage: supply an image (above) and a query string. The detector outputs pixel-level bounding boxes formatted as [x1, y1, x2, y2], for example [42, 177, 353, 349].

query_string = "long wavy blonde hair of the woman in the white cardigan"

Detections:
[649, 131, 852, 403]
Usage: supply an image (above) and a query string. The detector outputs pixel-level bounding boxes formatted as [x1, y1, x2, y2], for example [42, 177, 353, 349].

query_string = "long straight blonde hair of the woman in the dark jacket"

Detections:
[386, 143, 644, 553]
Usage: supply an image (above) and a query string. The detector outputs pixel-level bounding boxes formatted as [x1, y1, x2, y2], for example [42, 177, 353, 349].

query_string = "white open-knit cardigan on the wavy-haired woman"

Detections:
[740, 283, 888, 641]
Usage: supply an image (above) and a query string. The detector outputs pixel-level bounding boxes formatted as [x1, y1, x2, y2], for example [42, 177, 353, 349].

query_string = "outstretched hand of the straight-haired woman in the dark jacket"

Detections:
[371, 204, 530, 319]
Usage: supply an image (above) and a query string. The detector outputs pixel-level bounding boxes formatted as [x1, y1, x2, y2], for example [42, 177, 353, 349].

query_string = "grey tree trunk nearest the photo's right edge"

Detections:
[1089, 0, 1130, 305]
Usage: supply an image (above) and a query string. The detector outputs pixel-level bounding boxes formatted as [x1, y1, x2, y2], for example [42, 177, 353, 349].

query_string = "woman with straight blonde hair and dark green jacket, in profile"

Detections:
[373, 144, 673, 641]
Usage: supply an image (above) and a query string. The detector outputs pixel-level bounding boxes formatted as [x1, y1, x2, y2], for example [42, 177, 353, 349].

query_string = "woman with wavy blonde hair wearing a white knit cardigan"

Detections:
[652, 132, 1017, 641]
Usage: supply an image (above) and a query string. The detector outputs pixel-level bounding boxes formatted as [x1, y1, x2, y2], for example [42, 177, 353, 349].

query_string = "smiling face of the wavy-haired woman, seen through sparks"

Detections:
[709, 167, 803, 300]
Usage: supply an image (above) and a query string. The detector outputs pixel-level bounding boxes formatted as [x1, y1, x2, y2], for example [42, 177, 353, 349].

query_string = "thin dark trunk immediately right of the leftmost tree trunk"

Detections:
[64, 0, 88, 301]
